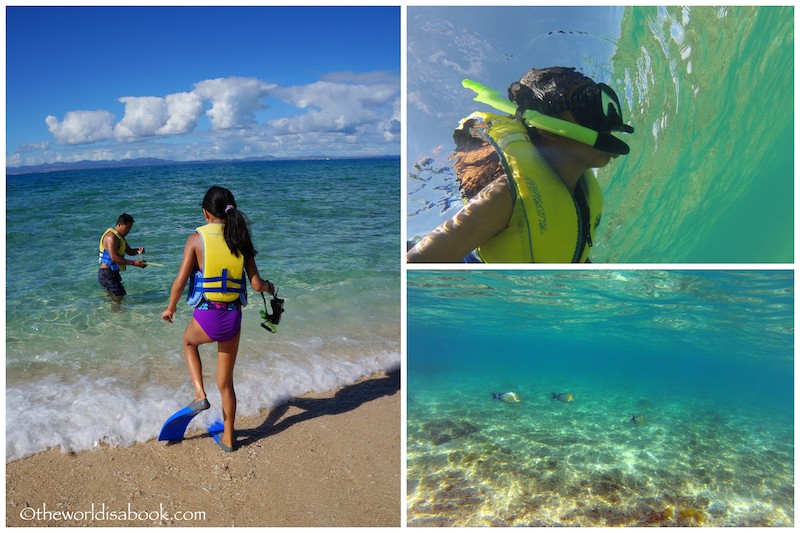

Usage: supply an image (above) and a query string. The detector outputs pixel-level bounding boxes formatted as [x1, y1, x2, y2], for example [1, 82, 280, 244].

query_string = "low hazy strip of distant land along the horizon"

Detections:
[6, 155, 400, 176]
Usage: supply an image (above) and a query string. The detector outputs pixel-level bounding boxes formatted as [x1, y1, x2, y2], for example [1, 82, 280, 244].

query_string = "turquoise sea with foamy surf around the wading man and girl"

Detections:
[6, 158, 400, 460]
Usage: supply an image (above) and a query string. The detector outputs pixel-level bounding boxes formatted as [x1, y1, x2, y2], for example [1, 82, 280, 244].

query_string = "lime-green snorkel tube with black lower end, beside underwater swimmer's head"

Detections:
[461, 80, 633, 155]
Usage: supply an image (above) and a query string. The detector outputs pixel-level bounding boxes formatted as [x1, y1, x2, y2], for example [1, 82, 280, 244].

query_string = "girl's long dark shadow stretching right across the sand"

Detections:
[236, 367, 400, 448]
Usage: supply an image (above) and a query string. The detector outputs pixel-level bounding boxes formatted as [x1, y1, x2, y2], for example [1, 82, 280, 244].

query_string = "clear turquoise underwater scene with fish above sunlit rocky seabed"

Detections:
[407, 270, 794, 527]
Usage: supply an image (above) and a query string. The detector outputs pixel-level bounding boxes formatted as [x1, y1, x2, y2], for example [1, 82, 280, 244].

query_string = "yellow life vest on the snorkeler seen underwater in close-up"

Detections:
[459, 112, 603, 263]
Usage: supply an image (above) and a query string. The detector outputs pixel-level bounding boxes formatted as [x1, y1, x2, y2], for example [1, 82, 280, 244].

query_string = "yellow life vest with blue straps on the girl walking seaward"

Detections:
[186, 223, 247, 307]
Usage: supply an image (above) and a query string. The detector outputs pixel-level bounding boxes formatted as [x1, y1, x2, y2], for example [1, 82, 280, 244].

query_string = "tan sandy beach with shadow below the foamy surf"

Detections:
[6, 370, 402, 527]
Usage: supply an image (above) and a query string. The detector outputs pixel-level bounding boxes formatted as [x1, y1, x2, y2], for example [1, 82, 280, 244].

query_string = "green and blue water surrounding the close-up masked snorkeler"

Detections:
[407, 6, 794, 263]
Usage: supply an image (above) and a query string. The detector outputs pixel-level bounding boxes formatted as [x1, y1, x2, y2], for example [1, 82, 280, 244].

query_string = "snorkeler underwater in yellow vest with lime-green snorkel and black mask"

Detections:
[407, 67, 633, 263]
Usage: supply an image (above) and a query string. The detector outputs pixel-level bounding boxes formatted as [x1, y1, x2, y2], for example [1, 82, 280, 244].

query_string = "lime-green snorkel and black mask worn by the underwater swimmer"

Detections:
[461, 80, 633, 155]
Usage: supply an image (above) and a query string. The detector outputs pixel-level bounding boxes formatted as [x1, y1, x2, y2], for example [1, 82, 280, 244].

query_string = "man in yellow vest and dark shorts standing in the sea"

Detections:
[97, 213, 147, 303]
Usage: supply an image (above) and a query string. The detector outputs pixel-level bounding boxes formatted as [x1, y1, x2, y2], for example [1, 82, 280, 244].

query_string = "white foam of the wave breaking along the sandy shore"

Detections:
[6, 351, 400, 461]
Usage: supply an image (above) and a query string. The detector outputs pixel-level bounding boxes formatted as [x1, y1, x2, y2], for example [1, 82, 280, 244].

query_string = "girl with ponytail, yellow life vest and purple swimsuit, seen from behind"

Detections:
[161, 186, 275, 452]
